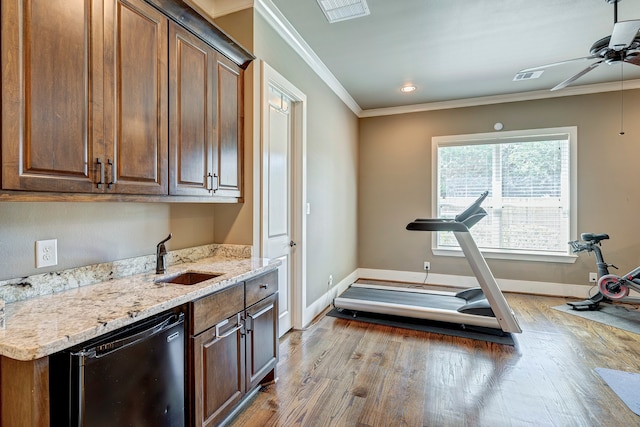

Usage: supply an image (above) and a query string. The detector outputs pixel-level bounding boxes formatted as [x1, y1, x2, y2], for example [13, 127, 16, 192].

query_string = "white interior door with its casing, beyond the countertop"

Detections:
[260, 62, 306, 336]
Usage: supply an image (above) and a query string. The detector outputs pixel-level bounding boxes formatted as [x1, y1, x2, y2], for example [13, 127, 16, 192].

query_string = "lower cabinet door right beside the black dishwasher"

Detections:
[192, 314, 245, 426]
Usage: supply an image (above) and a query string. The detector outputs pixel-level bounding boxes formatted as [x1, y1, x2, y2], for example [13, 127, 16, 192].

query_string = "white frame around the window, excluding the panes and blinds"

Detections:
[431, 126, 578, 263]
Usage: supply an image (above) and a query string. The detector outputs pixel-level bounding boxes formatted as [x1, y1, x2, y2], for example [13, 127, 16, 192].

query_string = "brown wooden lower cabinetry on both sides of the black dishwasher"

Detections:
[0, 270, 278, 427]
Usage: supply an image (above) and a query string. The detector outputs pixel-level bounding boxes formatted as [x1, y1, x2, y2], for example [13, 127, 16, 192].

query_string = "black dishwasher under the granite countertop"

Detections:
[49, 312, 185, 427]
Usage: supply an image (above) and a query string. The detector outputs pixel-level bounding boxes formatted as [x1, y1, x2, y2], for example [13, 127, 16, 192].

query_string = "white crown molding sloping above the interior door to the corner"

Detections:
[254, 0, 362, 117]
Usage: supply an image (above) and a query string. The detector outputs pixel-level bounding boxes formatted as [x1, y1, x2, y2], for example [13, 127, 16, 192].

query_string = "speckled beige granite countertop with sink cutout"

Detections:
[0, 256, 279, 360]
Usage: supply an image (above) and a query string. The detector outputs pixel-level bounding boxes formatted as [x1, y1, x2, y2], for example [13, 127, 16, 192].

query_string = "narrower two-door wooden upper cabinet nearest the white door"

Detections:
[169, 24, 243, 198]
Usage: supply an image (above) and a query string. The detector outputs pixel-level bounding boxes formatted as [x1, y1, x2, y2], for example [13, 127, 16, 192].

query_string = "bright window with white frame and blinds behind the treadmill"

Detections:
[432, 127, 577, 262]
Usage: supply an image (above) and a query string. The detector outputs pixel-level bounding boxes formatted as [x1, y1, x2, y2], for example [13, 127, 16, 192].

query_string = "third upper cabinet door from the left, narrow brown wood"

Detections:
[169, 23, 217, 196]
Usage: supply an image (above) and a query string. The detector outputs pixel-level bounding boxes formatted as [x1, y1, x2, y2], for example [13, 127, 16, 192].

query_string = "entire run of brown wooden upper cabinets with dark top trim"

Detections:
[0, 0, 253, 200]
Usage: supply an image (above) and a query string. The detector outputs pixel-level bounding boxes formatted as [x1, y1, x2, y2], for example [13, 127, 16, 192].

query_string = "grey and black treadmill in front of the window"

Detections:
[333, 191, 522, 333]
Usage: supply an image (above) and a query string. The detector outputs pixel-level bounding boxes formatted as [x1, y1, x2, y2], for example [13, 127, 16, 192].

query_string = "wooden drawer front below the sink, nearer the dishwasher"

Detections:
[190, 282, 244, 335]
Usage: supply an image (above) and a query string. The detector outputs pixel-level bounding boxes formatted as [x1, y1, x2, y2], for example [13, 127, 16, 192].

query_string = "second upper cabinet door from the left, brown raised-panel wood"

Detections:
[103, 0, 169, 194]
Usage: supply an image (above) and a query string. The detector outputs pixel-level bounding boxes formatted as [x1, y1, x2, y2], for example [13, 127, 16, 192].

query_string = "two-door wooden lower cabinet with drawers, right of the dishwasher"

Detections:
[189, 271, 278, 427]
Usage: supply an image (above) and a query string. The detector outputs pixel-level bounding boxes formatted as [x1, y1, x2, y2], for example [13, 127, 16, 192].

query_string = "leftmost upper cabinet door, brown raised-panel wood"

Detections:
[0, 0, 102, 193]
